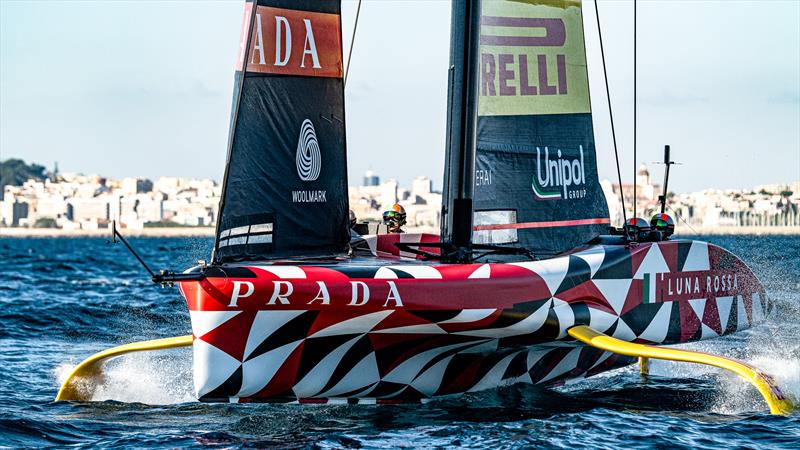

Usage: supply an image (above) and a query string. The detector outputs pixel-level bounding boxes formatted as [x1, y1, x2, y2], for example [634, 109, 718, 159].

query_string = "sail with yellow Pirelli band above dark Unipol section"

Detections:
[473, 0, 610, 255]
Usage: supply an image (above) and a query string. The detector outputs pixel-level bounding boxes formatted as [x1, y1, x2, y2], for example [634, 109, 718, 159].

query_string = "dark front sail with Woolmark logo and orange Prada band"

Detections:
[214, 0, 349, 262]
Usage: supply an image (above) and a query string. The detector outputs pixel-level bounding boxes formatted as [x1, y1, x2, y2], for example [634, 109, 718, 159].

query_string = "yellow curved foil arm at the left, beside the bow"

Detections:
[56, 335, 192, 401]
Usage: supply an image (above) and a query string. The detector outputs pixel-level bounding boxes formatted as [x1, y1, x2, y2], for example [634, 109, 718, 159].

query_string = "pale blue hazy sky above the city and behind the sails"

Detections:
[0, 0, 800, 192]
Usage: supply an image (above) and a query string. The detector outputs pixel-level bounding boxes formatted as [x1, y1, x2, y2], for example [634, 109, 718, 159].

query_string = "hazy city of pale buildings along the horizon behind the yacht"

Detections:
[0, 165, 800, 232]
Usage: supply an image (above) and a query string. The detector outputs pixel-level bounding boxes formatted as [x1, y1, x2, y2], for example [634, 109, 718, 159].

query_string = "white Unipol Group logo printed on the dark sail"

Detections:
[531, 146, 586, 200]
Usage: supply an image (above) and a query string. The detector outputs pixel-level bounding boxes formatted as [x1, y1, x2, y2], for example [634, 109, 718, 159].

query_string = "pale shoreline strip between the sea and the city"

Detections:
[0, 225, 800, 238]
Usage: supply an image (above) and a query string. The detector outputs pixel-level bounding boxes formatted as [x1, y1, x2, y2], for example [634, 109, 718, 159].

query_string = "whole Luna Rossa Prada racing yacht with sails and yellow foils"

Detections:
[57, 0, 791, 413]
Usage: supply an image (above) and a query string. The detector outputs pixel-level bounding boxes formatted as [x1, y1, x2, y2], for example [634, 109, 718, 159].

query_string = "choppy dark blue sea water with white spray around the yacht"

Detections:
[0, 237, 800, 448]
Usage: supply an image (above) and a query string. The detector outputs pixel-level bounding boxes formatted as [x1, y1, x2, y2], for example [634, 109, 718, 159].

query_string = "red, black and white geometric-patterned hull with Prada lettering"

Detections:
[181, 240, 771, 402]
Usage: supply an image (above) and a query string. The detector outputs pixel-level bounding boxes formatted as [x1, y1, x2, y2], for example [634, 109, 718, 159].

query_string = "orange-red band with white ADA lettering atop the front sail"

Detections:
[236, 6, 342, 78]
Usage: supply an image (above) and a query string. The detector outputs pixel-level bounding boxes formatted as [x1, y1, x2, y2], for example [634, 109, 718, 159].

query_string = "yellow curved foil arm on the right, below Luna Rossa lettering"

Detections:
[567, 325, 794, 414]
